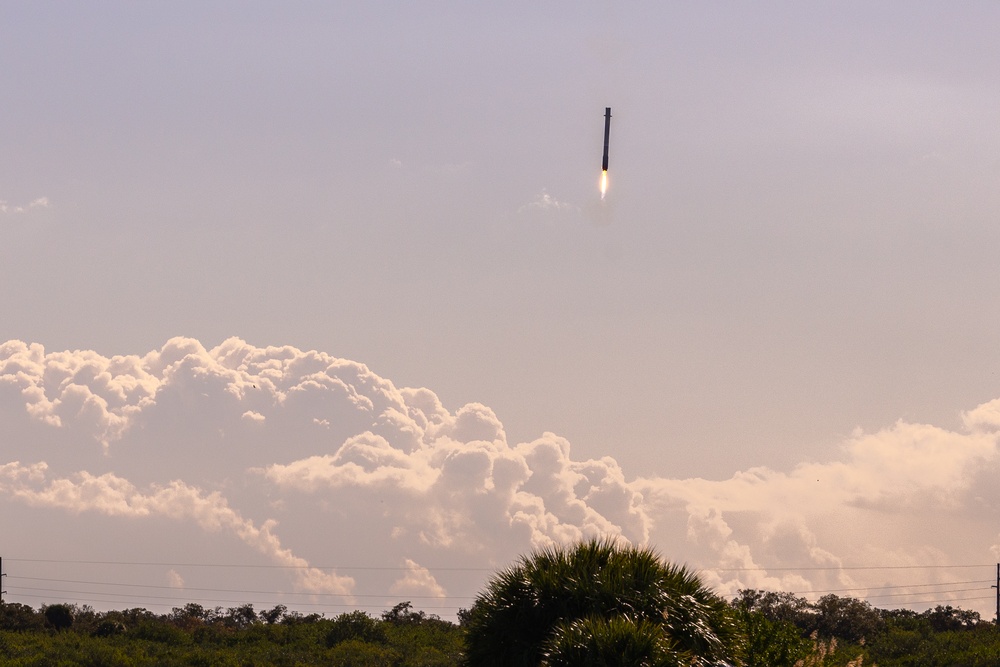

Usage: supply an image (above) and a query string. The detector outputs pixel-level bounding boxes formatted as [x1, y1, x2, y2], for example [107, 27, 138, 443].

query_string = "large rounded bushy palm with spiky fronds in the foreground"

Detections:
[466, 539, 735, 667]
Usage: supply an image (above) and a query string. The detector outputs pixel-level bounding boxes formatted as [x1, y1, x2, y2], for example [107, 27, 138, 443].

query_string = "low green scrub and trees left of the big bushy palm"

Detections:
[0, 602, 463, 667]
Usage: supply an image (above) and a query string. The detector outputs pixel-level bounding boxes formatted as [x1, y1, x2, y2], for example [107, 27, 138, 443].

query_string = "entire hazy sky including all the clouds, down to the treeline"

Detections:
[0, 0, 1000, 618]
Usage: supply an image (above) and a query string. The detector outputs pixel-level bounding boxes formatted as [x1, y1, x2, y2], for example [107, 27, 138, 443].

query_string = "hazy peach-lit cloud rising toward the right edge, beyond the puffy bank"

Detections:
[634, 422, 997, 592]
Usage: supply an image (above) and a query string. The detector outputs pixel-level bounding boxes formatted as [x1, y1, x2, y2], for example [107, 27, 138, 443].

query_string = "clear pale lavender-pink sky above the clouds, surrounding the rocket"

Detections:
[0, 2, 1000, 620]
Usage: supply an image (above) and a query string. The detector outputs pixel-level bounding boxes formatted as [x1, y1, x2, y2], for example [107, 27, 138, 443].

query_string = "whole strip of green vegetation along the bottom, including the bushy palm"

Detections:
[0, 541, 1000, 667]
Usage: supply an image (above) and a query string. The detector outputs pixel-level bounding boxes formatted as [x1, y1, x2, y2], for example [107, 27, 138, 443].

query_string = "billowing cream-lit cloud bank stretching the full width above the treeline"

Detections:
[0, 338, 1000, 610]
